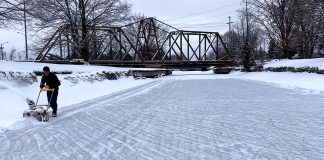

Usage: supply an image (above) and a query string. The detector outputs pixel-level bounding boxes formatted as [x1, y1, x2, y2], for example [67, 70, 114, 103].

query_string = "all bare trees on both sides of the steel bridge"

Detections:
[0, 0, 324, 63]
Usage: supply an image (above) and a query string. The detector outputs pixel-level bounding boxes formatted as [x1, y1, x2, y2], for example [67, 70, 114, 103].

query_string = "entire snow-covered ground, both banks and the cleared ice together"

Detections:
[0, 59, 324, 159]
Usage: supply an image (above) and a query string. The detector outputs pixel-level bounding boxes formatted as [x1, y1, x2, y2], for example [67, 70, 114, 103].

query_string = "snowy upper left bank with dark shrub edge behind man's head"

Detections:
[0, 61, 134, 86]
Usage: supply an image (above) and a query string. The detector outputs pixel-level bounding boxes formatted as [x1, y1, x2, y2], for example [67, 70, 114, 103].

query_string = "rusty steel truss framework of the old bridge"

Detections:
[36, 18, 231, 63]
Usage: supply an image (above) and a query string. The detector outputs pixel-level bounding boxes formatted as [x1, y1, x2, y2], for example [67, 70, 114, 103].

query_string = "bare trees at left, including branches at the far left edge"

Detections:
[0, 0, 132, 60]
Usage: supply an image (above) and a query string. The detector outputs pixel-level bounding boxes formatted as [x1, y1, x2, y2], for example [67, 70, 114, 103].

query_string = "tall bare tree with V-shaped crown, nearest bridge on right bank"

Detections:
[249, 0, 298, 58]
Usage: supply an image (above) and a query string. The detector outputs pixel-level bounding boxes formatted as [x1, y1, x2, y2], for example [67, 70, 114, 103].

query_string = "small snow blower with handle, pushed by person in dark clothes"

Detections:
[23, 85, 54, 122]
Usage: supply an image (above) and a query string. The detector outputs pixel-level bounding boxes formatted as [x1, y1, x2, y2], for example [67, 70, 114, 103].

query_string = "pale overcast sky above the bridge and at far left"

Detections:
[0, 0, 241, 56]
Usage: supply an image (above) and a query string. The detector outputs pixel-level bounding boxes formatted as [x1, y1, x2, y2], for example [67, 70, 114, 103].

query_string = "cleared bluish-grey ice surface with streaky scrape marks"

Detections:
[0, 79, 324, 160]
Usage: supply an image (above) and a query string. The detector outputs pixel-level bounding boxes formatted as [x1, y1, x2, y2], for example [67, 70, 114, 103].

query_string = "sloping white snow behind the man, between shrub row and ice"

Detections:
[0, 75, 152, 130]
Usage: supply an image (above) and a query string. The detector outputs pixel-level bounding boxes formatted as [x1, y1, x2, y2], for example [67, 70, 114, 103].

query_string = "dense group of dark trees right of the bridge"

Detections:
[224, 0, 324, 59]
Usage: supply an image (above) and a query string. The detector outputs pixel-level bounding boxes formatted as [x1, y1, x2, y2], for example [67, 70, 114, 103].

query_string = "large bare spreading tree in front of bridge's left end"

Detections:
[27, 0, 130, 61]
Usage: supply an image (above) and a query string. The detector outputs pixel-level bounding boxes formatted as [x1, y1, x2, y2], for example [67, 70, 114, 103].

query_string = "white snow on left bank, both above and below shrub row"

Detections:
[0, 61, 152, 132]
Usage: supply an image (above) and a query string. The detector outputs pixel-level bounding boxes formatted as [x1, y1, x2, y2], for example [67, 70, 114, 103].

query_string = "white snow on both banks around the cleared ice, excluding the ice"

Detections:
[0, 59, 324, 132]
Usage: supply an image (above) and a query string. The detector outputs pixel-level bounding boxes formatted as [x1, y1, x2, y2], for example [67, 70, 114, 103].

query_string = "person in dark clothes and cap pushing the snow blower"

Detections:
[40, 66, 61, 117]
